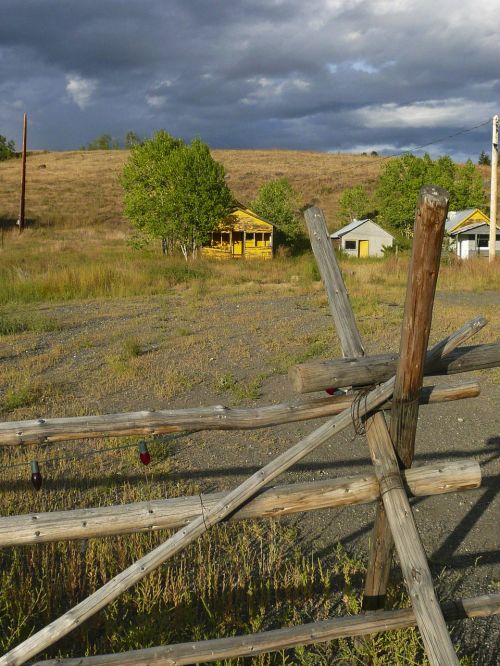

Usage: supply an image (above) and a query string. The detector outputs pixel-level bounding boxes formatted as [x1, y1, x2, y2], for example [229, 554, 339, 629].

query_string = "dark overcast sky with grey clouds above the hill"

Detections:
[0, 0, 500, 161]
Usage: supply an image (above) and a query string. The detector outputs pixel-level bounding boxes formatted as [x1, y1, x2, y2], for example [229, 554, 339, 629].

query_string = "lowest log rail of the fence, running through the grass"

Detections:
[33, 594, 500, 666]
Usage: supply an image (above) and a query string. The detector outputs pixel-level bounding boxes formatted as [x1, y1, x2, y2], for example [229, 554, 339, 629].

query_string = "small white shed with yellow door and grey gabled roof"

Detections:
[330, 219, 394, 257]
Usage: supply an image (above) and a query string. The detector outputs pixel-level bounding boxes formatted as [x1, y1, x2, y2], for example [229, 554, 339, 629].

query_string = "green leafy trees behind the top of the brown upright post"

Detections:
[375, 153, 485, 232]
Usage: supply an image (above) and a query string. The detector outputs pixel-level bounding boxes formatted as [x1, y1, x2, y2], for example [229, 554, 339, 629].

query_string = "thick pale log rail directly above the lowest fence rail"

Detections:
[0, 460, 481, 547]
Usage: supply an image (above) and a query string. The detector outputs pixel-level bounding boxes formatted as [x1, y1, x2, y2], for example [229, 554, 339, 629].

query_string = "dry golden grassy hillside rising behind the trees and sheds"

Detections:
[0, 150, 383, 233]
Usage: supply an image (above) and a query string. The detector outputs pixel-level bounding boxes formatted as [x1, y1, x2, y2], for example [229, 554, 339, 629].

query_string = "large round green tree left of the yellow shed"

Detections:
[121, 130, 232, 259]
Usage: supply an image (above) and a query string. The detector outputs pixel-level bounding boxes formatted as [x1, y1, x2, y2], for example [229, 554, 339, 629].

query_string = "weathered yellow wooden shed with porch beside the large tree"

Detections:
[201, 205, 274, 259]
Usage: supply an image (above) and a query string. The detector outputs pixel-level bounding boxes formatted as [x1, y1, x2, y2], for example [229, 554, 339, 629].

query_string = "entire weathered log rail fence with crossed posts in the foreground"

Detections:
[0, 187, 500, 666]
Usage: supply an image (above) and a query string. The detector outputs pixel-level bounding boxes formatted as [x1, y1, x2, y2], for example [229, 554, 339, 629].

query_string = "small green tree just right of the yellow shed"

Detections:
[250, 178, 302, 245]
